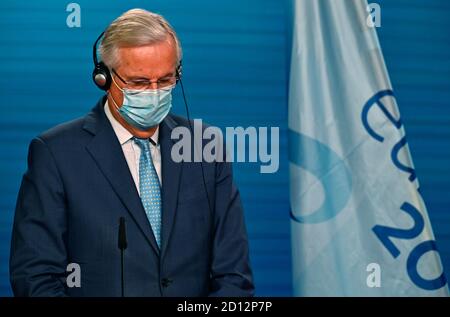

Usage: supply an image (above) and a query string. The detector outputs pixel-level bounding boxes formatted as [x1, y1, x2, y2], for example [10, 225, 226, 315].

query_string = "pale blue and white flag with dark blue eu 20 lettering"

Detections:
[289, 0, 448, 296]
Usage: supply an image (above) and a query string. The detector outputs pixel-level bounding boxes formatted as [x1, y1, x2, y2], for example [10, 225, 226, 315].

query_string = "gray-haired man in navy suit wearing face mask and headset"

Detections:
[10, 9, 254, 296]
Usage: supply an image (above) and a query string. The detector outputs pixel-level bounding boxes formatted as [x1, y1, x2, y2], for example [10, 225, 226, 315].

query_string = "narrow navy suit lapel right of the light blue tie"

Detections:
[159, 115, 182, 257]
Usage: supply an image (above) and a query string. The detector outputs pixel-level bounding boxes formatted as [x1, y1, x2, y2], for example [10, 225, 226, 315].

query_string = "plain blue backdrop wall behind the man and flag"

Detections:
[0, 0, 450, 296]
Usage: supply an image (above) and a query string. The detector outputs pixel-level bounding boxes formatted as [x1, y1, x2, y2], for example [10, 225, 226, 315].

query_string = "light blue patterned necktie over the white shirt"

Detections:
[133, 138, 161, 247]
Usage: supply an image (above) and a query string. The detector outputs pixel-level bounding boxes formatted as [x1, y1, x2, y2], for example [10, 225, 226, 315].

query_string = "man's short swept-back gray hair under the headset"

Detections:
[100, 9, 182, 68]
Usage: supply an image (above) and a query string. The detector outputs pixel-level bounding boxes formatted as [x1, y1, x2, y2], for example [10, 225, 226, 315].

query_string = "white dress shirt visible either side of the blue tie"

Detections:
[104, 101, 162, 194]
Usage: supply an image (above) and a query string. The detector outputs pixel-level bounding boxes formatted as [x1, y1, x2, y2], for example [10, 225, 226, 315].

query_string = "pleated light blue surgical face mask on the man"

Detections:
[111, 78, 174, 130]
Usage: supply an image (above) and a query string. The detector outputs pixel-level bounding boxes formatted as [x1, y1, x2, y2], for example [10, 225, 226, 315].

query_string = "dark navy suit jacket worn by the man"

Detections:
[10, 97, 254, 296]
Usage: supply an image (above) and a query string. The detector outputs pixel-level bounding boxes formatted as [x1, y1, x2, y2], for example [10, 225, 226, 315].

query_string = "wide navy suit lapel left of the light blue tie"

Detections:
[84, 98, 161, 254]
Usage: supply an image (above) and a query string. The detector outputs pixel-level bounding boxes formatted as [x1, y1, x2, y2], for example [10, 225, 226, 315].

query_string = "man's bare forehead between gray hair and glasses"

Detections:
[117, 41, 177, 79]
